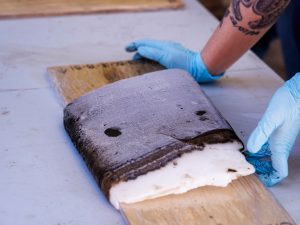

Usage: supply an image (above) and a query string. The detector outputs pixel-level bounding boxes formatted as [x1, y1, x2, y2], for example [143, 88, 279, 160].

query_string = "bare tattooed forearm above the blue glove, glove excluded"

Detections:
[202, 0, 290, 74]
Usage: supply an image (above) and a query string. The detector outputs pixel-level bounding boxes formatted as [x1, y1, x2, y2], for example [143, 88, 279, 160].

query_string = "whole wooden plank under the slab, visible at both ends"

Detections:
[48, 61, 296, 225]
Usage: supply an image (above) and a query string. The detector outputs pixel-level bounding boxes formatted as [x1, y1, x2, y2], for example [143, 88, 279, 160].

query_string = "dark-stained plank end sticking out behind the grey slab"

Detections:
[48, 60, 164, 104]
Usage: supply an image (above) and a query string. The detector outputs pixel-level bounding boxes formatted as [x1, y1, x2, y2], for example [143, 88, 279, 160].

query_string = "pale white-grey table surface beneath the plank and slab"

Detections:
[0, 0, 300, 225]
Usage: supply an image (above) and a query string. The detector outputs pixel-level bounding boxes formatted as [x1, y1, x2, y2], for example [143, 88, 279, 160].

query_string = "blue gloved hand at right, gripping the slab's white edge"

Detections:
[246, 73, 300, 186]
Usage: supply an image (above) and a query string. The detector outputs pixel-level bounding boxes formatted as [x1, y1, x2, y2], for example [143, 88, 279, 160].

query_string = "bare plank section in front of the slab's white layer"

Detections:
[121, 175, 296, 225]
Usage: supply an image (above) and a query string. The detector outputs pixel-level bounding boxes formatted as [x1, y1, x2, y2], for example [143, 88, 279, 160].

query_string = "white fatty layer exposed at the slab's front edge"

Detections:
[110, 142, 255, 209]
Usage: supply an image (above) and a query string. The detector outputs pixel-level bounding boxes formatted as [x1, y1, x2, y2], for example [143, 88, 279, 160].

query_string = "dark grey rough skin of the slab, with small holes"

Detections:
[64, 70, 244, 197]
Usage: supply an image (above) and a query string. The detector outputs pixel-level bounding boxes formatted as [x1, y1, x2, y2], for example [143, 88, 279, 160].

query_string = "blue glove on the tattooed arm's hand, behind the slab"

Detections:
[126, 39, 223, 83]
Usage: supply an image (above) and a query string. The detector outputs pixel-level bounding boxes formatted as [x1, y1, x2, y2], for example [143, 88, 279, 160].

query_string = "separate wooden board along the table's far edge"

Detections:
[0, 0, 184, 18]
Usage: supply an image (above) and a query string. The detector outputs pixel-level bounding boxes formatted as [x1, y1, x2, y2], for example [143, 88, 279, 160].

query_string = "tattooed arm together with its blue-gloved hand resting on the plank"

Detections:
[126, 0, 290, 78]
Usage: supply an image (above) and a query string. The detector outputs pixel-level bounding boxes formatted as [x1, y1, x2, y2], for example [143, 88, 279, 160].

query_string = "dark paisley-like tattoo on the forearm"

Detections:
[220, 0, 290, 35]
